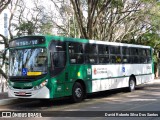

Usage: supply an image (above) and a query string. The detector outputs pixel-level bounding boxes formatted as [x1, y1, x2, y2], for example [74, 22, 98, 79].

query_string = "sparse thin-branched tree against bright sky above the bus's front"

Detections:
[10, 0, 53, 36]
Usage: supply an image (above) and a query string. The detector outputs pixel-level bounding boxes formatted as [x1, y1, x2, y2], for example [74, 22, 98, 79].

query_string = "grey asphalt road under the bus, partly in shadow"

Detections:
[0, 80, 160, 120]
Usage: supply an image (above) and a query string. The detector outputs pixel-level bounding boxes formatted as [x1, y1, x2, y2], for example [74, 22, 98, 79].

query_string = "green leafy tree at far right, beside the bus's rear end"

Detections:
[139, 1, 160, 77]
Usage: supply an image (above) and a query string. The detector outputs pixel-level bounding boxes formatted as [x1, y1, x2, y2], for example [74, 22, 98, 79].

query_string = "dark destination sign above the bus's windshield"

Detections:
[9, 36, 45, 47]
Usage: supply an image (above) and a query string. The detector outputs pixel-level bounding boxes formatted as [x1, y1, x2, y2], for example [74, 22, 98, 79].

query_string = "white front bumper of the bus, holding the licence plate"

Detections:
[8, 86, 50, 99]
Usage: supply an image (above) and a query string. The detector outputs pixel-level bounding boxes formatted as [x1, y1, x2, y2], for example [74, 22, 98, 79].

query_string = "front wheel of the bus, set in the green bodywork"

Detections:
[71, 82, 84, 103]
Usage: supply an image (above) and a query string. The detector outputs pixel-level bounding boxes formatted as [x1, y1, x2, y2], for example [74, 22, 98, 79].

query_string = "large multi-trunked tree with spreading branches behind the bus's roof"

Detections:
[70, 0, 154, 42]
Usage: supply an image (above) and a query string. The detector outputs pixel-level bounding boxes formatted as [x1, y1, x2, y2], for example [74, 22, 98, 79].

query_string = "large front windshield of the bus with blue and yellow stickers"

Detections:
[9, 48, 47, 76]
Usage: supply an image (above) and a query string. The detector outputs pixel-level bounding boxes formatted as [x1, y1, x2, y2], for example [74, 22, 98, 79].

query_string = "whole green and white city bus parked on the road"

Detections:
[8, 36, 154, 102]
